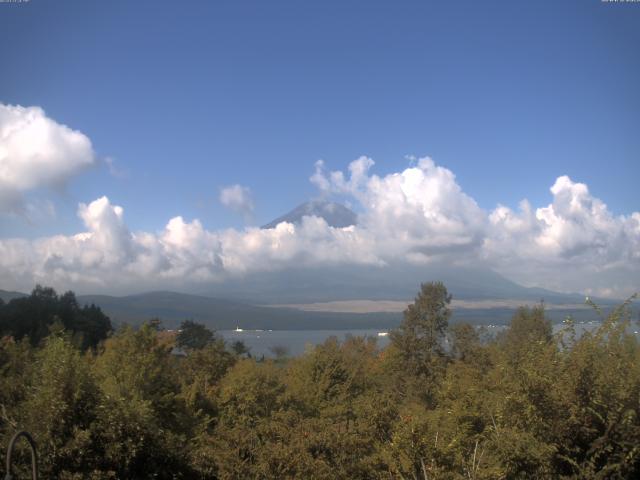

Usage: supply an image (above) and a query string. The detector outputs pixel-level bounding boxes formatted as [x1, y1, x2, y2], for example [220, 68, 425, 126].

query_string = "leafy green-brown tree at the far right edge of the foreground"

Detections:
[552, 296, 640, 478]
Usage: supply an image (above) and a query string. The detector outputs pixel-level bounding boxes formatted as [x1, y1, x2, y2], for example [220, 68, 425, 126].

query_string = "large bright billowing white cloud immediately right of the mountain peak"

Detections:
[312, 157, 485, 260]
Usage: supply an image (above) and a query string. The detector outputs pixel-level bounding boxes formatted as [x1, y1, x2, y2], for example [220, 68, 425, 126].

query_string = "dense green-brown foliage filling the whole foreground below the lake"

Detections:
[0, 284, 640, 479]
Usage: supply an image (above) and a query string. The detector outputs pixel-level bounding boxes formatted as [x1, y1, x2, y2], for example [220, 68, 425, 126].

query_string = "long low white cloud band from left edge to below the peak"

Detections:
[0, 197, 377, 291]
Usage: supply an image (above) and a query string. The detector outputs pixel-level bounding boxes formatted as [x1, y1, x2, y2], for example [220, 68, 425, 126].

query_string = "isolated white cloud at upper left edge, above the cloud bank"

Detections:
[0, 104, 95, 213]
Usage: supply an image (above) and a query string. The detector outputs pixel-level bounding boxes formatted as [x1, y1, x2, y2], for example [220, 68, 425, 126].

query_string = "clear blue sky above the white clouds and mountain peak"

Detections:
[0, 0, 640, 298]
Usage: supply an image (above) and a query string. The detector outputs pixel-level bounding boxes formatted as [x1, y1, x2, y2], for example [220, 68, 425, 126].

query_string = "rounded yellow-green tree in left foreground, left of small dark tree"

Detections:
[94, 324, 193, 478]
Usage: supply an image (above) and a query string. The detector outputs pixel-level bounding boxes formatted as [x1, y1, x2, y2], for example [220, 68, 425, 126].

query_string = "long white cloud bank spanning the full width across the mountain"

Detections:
[0, 152, 640, 297]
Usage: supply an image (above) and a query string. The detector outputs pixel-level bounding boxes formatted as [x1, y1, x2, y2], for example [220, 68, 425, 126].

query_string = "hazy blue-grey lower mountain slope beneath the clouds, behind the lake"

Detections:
[198, 263, 584, 304]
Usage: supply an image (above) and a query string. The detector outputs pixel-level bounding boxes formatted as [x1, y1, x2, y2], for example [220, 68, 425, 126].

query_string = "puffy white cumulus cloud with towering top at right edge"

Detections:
[482, 176, 640, 296]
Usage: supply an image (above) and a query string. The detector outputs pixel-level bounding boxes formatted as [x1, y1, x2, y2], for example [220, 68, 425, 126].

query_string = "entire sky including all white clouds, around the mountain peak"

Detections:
[0, 0, 640, 296]
